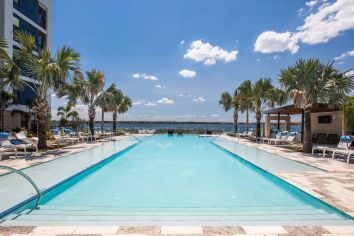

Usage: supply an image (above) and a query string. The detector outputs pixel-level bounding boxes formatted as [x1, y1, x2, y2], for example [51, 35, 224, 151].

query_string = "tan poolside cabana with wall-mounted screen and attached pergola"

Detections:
[263, 104, 351, 142]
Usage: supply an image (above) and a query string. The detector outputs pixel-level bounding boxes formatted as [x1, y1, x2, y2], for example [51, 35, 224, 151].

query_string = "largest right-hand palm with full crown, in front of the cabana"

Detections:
[279, 59, 354, 153]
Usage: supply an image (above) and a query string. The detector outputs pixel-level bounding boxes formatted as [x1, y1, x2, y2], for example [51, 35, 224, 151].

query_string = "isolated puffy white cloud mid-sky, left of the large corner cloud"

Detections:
[184, 40, 238, 65]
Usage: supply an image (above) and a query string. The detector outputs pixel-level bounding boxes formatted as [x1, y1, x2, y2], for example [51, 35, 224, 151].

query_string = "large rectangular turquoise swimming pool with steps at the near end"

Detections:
[0, 135, 353, 225]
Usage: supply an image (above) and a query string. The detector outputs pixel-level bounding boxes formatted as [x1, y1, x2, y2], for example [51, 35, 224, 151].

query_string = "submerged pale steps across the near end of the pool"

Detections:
[0, 205, 353, 226]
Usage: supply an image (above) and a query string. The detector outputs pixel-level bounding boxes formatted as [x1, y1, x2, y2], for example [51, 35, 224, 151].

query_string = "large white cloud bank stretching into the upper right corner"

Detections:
[254, 0, 354, 54]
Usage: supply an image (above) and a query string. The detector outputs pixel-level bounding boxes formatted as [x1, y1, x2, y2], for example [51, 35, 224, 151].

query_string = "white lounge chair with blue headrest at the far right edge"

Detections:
[312, 135, 354, 163]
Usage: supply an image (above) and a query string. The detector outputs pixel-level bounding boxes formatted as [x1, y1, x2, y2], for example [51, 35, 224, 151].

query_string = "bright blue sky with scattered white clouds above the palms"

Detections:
[52, 0, 354, 121]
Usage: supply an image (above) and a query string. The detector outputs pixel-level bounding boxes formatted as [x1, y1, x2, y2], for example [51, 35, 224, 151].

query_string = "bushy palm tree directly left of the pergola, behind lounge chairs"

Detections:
[250, 78, 286, 137]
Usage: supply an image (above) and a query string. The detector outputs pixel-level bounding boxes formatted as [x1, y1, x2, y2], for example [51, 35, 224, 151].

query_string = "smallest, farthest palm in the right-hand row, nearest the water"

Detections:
[219, 89, 240, 132]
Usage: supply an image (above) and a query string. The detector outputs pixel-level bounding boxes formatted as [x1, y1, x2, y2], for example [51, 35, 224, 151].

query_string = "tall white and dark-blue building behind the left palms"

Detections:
[0, 0, 52, 131]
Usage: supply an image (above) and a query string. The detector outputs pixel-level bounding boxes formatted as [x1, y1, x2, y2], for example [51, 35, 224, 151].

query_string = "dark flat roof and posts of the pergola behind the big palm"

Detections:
[263, 103, 339, 142]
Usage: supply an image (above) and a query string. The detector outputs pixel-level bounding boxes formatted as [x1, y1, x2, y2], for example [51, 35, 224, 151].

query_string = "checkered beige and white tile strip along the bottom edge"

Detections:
[0, 226, 354, 236]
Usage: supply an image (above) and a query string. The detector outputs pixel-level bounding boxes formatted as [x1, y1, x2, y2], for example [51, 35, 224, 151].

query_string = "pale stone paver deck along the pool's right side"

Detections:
[222, 135, 354, 218]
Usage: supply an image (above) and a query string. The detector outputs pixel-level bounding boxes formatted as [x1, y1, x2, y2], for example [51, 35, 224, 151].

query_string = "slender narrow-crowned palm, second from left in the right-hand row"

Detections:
[237, 80, 253, 130]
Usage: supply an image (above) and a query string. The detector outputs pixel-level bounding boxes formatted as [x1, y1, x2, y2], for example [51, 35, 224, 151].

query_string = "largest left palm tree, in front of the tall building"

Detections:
[1, 31, 80, 148]
